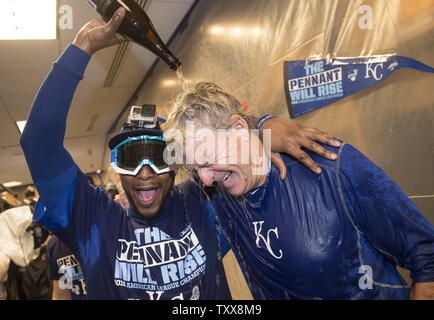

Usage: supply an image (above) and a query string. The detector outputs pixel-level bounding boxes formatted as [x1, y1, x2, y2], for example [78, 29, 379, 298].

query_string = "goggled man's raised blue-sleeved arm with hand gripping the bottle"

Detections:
[20, 9, 125, 207]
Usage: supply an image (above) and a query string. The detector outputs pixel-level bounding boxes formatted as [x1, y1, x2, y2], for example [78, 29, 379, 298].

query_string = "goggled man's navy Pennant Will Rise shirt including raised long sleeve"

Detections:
[20, 45, 231, 300]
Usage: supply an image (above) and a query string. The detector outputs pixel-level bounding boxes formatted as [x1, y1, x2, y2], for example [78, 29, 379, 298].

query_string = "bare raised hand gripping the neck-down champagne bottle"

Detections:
[72, 7, 127, 55]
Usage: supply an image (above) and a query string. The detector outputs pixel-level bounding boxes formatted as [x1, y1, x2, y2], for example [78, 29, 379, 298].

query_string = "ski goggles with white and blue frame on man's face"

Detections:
[111, 135, 171, 176]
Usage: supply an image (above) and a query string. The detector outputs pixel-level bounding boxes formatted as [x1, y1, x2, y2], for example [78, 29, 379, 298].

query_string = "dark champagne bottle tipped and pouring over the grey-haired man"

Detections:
[87, 0, 181, 71]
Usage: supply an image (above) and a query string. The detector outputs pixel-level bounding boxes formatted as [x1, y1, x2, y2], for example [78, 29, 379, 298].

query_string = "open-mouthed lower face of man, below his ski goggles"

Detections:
[121, 166, 174, 220]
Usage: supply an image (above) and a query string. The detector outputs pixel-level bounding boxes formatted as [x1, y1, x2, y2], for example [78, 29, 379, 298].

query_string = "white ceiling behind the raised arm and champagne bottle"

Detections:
[0, 0, 194, 184]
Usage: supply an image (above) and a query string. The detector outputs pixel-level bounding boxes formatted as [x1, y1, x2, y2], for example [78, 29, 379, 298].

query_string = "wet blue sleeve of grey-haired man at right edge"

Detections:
[338, 144, 434, 282]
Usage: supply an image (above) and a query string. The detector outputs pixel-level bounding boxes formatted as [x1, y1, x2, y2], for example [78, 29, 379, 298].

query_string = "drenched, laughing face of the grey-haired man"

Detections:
[185, 117, 267, 197]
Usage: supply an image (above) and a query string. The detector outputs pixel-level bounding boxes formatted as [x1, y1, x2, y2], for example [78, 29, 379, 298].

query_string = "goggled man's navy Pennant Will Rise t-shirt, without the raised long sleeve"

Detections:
[34, 171, 231, 300]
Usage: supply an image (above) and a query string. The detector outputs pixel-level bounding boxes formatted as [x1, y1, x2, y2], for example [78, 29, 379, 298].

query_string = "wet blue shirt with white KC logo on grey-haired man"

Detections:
[209, 144, 434, 299]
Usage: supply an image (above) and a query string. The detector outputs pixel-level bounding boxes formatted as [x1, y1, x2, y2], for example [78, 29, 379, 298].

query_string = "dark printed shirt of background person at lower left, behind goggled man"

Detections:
[47, 235, 86, 300]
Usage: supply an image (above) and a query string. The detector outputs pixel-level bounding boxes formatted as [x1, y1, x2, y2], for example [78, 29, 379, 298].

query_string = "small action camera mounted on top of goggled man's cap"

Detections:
[123, 104, 159, 130]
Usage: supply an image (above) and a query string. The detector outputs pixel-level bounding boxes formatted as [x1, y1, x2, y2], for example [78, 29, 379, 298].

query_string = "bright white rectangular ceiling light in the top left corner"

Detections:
[0, 0, 57, 40]
